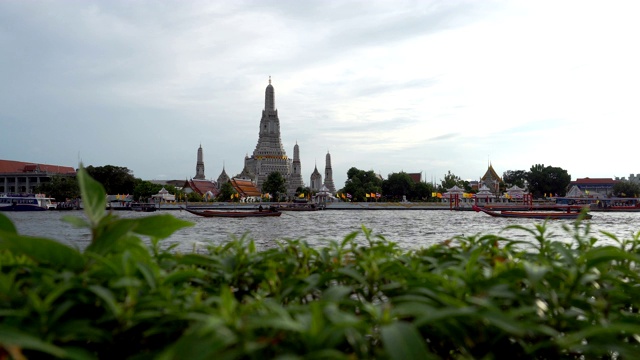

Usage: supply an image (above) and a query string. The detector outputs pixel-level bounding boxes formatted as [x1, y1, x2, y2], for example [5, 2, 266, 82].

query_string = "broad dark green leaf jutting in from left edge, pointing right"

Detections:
[0, 233, 84, 271]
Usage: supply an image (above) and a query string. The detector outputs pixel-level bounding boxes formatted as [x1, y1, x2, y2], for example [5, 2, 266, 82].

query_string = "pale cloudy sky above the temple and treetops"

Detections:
[0, 0, 640, 189]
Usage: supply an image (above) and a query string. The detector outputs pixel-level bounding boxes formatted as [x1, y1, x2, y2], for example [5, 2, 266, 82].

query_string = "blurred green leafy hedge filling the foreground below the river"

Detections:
[0, 169, 640, 360]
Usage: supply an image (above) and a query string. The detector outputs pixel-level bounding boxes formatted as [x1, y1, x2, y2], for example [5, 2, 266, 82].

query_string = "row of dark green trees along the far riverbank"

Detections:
[36, 164, 640, 201]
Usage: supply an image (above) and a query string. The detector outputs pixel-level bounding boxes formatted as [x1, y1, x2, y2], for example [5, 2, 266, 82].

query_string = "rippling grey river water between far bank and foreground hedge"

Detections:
[4, 210, 640, 252]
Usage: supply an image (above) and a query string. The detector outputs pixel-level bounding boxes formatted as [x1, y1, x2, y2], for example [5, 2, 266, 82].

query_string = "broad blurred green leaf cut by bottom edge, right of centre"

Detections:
[380, 322, 437, 360]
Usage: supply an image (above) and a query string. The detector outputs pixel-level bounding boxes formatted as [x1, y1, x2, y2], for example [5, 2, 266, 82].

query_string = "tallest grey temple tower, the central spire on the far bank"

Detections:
[245, 77, 291, 189]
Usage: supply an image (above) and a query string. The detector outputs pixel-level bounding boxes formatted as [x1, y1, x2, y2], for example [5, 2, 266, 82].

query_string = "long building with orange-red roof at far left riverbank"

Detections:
[0, 160, 76, 194]
